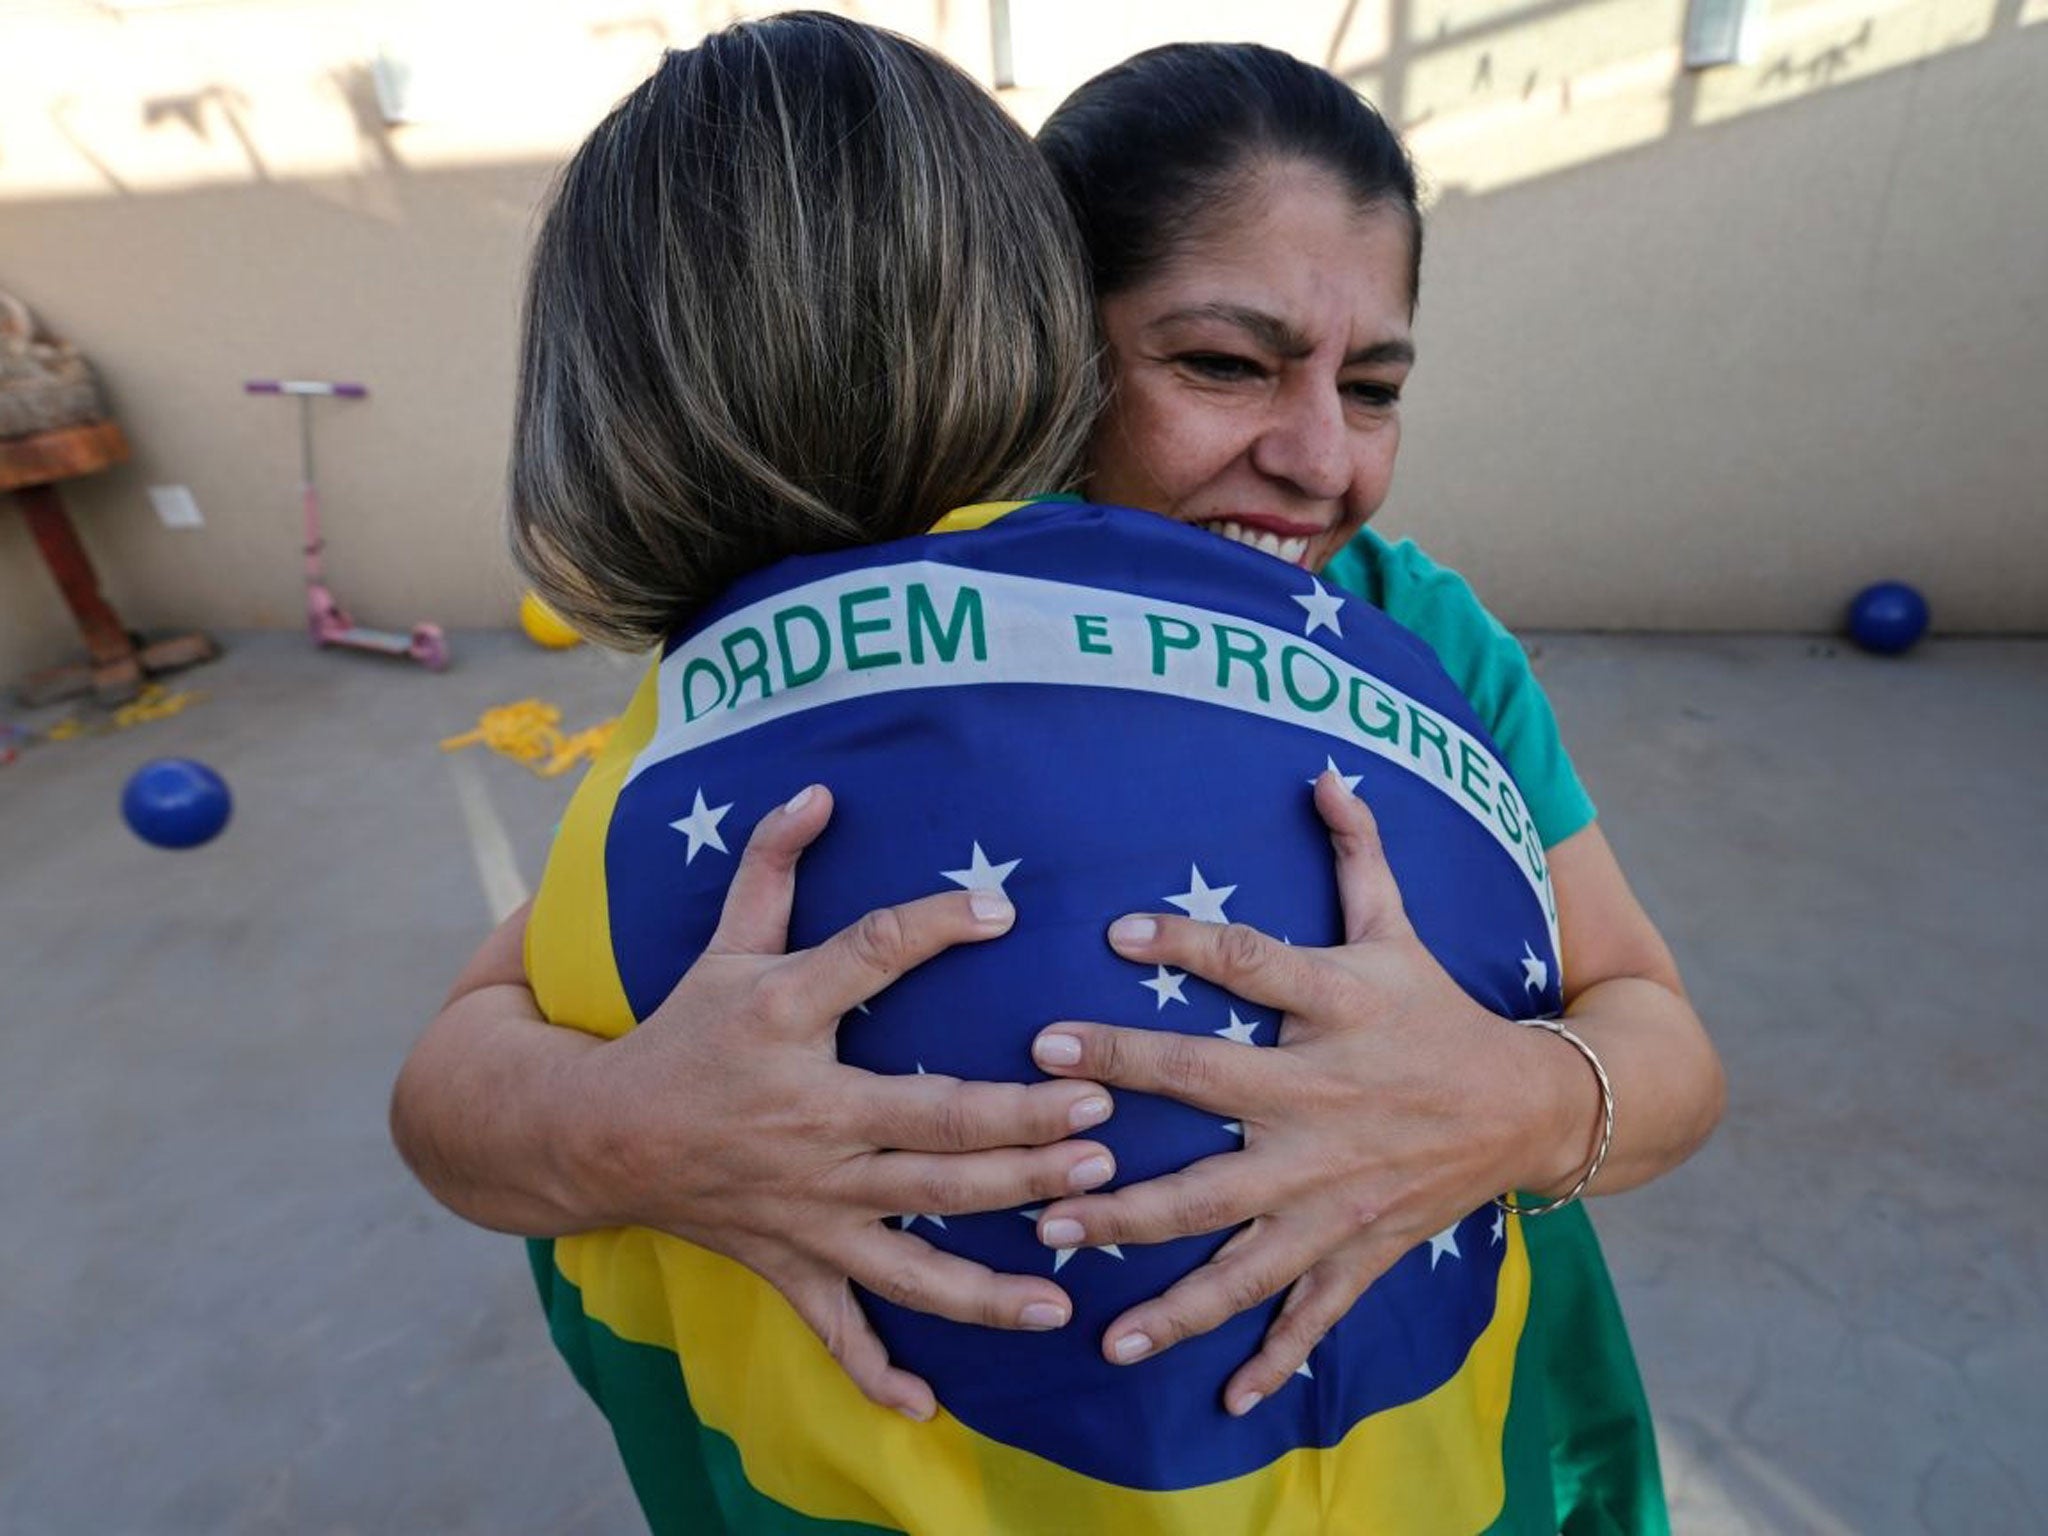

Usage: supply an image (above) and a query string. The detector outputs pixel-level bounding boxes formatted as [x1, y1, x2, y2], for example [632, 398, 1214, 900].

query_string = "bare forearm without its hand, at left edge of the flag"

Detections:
[391, 981, 608, 1237]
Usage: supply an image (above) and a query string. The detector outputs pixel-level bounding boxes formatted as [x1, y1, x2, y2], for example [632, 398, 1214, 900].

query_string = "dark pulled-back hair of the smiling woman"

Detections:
[1038, 43, 1421, 307]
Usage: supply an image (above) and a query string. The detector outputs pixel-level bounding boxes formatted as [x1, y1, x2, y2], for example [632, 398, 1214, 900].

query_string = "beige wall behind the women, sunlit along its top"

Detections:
[0, 0, 2048, 676]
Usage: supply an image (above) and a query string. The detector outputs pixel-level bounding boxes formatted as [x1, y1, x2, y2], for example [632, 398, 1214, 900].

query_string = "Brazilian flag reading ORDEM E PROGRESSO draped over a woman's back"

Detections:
[528, 502, 1561, 1536]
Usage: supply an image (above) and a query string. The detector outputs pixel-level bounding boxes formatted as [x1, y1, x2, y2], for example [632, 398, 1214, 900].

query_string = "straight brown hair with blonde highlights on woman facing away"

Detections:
[510, 12, 1098, 647]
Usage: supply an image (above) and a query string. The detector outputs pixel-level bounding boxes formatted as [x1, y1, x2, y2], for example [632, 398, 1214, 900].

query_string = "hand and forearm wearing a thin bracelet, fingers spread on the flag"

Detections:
[1034, 774, 1720, 1413]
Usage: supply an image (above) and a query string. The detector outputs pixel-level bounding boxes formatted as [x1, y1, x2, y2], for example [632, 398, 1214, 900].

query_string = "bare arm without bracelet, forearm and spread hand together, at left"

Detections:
[393, 788, 1114, 1419]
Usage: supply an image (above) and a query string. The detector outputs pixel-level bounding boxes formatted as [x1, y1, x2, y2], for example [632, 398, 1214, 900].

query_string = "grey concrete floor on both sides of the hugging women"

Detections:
[0, 635, 2048, 1536]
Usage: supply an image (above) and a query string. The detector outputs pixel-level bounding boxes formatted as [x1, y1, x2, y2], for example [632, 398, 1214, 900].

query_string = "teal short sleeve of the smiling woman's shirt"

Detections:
[1323, 528, 1595, 848]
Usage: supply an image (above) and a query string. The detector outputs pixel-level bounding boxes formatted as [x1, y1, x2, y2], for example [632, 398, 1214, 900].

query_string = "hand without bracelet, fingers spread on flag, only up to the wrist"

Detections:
[588, 788, 1138, 1417]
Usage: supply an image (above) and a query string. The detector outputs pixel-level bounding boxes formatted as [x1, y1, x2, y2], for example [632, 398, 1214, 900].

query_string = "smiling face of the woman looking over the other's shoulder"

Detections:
[1087, 162, 1415, 571]
